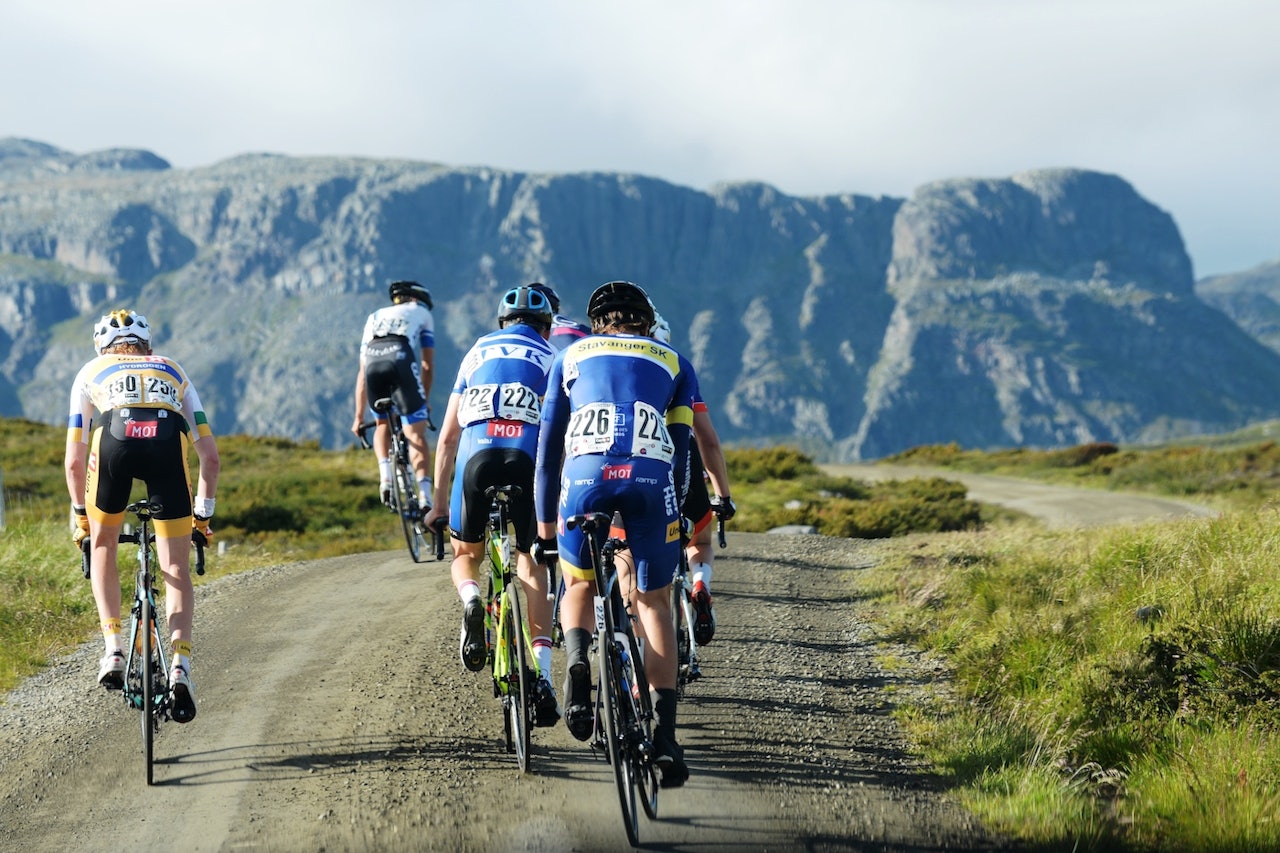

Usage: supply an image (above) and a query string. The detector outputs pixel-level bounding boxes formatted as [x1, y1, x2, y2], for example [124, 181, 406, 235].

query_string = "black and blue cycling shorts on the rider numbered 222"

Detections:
[449, 447, 538, 552]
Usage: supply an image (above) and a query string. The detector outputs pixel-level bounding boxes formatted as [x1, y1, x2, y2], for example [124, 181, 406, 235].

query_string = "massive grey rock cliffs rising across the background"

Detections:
[0, 140, 1280, 460]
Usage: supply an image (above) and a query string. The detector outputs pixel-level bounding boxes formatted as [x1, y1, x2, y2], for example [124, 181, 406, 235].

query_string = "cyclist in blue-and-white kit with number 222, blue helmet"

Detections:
[426, 286, 561, 726]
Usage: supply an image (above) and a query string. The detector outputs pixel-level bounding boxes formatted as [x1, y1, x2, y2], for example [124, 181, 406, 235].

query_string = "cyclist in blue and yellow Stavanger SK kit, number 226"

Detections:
[536, 282, 695, 788]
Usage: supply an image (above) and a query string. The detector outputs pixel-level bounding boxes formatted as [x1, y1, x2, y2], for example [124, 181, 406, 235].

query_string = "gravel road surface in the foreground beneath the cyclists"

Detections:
[0, 471, 1208, 853]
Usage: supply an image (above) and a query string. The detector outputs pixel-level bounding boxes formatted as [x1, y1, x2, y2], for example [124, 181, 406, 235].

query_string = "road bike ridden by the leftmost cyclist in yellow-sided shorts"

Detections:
[81, 500, 206, 785]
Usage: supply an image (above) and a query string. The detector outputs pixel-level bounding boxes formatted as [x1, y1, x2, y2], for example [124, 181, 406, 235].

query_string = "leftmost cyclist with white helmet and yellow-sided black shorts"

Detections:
[64, 310, 219, 722]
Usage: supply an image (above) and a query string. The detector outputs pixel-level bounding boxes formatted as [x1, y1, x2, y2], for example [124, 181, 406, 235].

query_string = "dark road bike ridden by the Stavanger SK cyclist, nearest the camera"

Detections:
[564, 512, 658, 847]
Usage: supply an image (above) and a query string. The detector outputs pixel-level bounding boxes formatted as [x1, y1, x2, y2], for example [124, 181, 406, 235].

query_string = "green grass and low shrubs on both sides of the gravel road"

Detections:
[0, 412, 1280, 852]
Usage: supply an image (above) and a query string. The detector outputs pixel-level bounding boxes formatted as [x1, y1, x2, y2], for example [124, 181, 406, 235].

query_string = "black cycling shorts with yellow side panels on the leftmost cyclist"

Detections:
[84, 406, 191, 535]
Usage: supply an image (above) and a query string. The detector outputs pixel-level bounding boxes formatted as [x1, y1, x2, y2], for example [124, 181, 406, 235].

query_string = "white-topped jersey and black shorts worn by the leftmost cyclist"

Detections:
[67, 353, 212, 537]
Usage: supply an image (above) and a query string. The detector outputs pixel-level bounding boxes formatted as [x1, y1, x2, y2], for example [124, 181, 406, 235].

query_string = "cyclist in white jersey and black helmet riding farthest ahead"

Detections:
[351, 282, 435, 511]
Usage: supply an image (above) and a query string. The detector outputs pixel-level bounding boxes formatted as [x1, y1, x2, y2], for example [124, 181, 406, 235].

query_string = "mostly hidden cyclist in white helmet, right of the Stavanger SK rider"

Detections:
[652, 314, 737, 637]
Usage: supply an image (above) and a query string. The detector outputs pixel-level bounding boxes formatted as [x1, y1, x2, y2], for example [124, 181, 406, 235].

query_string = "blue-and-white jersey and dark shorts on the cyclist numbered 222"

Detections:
[449, 323, 556, 540]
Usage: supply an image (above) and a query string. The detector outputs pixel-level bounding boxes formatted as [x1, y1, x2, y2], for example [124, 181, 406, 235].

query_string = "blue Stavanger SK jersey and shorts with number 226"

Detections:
[535, 334, 696, 590]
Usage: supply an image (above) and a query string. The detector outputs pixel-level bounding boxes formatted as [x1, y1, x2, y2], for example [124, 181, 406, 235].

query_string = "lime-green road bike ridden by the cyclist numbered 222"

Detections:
[484, 485, 554, 772]
